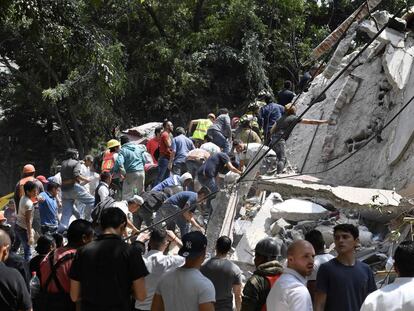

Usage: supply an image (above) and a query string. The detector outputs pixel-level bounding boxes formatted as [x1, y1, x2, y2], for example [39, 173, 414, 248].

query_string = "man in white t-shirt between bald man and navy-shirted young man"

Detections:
[305, 230, 335, 300]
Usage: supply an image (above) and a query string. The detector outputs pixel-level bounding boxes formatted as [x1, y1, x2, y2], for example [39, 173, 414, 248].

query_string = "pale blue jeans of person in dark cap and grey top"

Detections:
[59, 184, 95, 232]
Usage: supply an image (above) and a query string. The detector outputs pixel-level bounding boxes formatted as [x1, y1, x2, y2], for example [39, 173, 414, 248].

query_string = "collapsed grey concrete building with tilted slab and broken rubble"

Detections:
[207, 5, 414, 282]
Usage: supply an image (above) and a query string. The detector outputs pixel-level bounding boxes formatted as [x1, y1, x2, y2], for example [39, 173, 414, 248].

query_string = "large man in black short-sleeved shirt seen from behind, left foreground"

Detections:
[70, 208, 148, 311]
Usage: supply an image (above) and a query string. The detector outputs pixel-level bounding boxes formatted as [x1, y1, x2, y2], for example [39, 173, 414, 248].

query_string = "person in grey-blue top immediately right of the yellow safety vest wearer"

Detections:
[207, 108, 232, 154]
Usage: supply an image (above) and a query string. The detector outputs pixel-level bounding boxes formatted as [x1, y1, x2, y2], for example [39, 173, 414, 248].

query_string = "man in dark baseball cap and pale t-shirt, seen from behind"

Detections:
[151, 231, 216, 311]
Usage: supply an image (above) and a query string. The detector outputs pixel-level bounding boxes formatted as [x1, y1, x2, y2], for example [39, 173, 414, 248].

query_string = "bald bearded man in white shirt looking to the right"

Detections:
[266, 240, 315, 311]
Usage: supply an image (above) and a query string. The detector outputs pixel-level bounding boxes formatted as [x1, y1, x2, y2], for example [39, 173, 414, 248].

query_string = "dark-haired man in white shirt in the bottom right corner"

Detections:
[361, 241, 414, 311]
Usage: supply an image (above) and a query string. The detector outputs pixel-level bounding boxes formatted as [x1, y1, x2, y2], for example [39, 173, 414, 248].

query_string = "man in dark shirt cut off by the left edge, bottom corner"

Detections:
[0, 229, 32, 311]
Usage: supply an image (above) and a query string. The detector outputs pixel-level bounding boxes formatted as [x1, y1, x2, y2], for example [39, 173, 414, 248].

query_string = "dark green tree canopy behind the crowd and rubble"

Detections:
[0, 0, 403, 192]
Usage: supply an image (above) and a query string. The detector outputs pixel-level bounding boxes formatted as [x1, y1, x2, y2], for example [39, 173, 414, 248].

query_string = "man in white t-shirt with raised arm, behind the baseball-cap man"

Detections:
[135, 229, 185, 311]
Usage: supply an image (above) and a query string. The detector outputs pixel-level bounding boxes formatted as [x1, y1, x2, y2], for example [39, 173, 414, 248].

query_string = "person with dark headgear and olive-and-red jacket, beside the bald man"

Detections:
[241, 238, 283, 311]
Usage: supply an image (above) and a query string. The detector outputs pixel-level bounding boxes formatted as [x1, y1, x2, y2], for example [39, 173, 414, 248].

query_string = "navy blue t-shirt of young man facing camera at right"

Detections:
[316, 258, 377, 311]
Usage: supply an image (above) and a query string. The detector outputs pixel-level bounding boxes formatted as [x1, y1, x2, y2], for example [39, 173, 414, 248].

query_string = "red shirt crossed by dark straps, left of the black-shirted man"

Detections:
[40, 247, 76, 293]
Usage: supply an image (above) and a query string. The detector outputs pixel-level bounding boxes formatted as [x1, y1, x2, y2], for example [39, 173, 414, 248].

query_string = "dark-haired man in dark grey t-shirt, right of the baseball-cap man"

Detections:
[200, 236, 242, 311]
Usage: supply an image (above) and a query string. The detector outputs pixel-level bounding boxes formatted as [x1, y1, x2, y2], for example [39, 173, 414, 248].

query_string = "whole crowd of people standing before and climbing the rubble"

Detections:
[0, 81, 414, 311]
